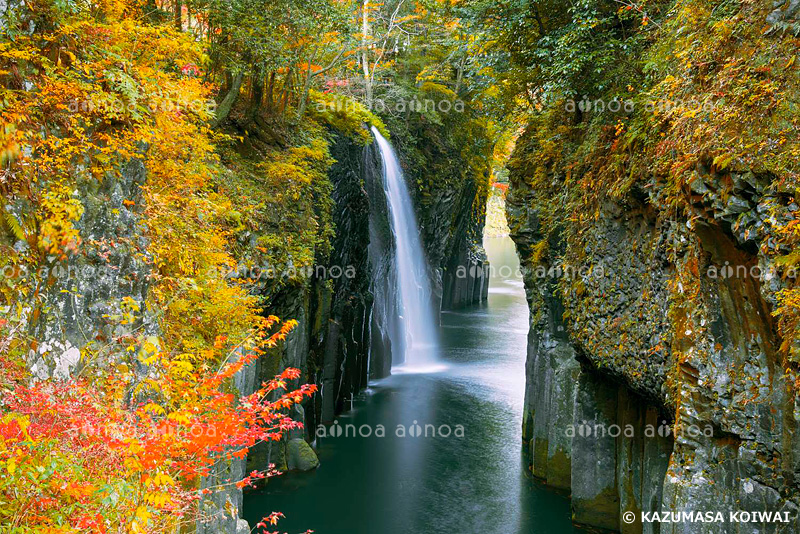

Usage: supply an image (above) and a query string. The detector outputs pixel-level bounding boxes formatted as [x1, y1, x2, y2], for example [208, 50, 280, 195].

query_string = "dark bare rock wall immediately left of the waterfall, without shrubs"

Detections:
[248, 135, 384, 480]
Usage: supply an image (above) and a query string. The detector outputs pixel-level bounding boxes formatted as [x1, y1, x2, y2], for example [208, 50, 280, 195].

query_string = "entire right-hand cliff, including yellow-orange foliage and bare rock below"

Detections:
[508, 2, 800, 533]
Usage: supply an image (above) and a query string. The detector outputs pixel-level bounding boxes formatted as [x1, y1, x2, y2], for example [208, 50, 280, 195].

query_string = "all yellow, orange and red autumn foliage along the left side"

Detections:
[0, 0, 315, 532]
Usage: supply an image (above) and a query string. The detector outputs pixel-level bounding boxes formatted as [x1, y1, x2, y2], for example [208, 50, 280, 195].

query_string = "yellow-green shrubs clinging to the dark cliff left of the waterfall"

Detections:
[217, 124, 334, 298]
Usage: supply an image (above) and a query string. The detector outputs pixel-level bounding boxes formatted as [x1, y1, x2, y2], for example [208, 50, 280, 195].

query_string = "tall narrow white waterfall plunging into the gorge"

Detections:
[372, 126, 441, 372]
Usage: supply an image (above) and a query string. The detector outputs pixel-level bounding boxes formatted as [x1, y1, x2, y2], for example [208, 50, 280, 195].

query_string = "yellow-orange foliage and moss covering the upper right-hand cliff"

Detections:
[509, 0, 800, 383]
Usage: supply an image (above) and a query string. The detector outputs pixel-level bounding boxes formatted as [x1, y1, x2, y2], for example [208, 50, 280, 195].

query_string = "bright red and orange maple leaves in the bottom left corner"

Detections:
[0, 359, 314, 532]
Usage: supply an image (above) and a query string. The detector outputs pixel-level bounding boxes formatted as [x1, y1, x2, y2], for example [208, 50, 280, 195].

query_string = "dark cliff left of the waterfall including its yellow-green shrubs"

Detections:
[212, 124, 384, 482]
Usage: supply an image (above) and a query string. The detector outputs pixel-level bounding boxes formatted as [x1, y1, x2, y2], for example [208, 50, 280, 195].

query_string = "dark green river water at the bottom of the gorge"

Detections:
[244, 238, 574, 534]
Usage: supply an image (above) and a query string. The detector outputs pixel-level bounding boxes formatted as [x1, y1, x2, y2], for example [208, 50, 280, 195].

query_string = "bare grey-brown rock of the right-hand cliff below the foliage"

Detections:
[507, 138, 800, 534]
